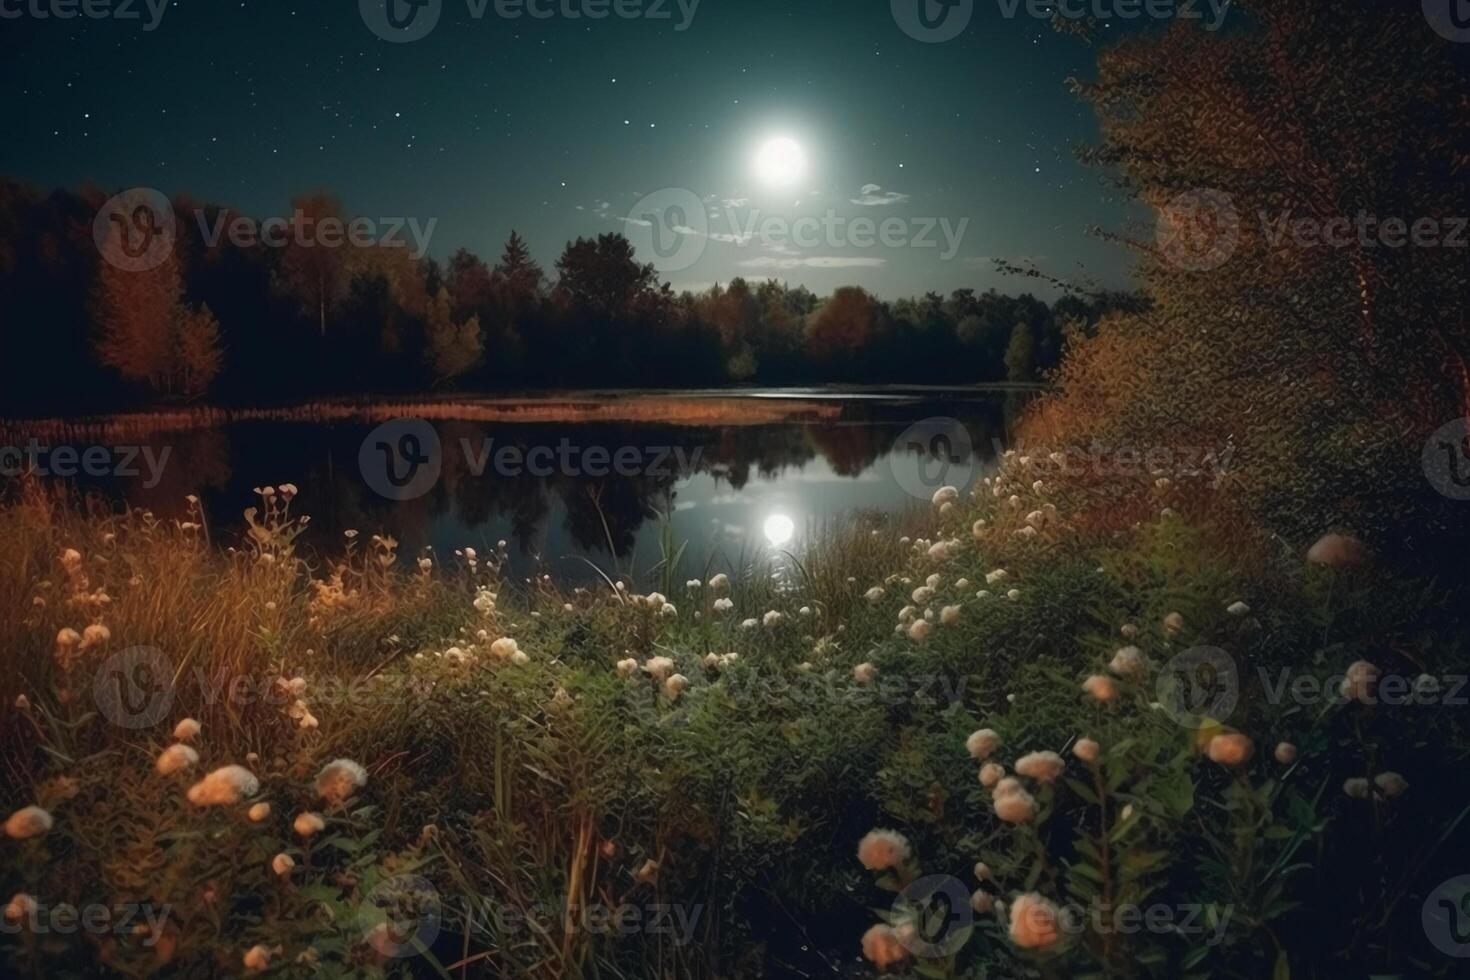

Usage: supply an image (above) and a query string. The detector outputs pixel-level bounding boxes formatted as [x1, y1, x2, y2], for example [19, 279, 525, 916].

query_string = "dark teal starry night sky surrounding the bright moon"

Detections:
[0, 0, 1130, 298]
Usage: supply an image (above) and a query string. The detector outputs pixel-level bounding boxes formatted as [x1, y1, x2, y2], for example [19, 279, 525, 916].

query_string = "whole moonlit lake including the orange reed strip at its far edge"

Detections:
[0, 388, 1028, 580]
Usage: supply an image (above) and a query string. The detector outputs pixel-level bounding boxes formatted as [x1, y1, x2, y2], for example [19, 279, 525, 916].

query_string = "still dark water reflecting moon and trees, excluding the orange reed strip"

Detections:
[11, 389, 1023, 580]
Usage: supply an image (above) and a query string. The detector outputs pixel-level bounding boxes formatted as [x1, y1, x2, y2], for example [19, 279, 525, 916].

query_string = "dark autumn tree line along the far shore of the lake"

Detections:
[0, 178, 1142, 416]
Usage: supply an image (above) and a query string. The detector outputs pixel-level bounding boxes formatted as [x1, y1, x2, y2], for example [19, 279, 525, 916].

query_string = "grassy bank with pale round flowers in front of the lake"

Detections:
[0, 453, 1470, 977]
